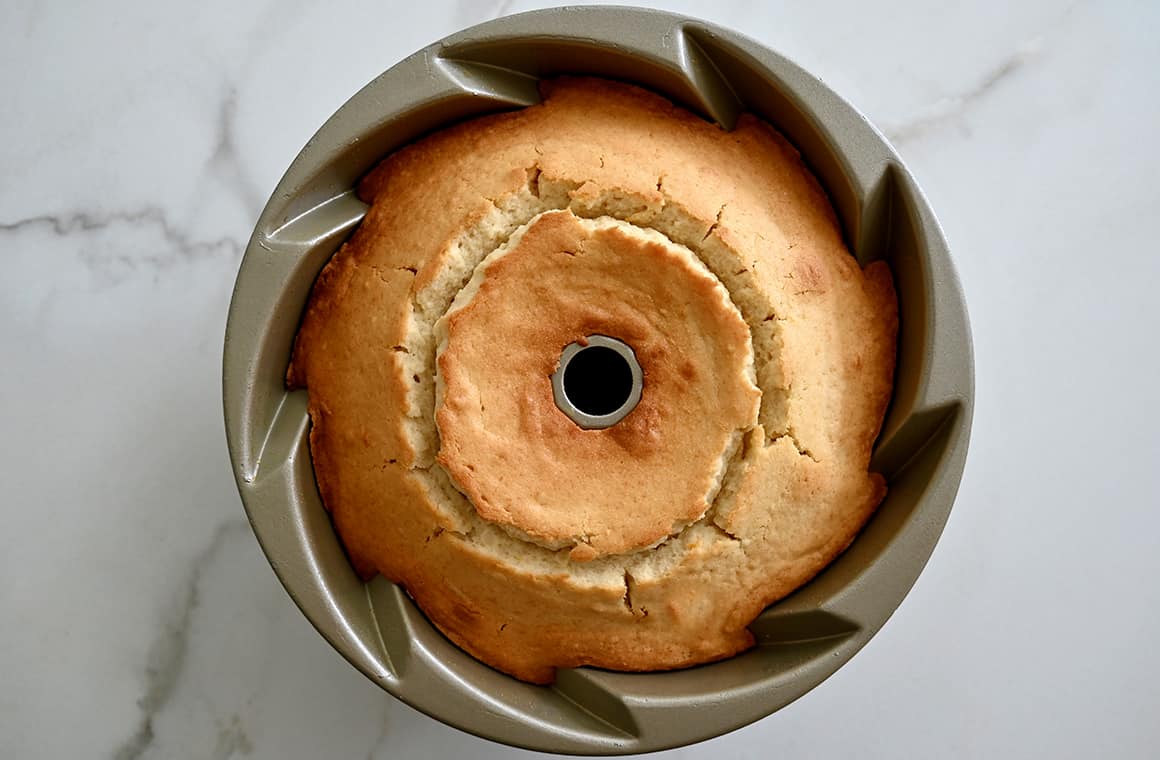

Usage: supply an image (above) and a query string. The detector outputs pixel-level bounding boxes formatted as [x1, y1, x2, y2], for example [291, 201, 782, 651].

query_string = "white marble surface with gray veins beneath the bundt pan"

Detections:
[0, 0, 1160, 760]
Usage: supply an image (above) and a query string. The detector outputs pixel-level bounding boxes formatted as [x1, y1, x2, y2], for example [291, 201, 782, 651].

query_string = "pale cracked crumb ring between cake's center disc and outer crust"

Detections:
[394, 174, 788, 577]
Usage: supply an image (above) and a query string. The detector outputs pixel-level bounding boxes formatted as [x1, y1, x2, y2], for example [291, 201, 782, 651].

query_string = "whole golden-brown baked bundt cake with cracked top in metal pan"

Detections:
[288, 78, 898, 683]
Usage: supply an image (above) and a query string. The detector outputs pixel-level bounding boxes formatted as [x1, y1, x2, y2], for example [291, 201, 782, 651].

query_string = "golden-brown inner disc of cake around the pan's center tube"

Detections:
[435, 210, 760, 559]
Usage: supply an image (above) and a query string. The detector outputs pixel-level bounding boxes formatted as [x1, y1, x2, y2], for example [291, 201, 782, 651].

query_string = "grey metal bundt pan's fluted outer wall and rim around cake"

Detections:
[224, 7, 973, 754]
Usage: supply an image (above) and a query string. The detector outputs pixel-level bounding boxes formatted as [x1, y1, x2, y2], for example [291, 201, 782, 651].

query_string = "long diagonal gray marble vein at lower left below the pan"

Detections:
[113, 519, 249, 760]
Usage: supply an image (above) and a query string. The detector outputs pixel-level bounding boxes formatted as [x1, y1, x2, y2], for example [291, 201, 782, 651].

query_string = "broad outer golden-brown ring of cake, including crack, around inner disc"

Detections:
[288, 79, 897, 682]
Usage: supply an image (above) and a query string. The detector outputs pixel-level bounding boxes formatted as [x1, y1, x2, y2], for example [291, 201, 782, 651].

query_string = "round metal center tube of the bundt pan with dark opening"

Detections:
[552, 335, 643, 429]
